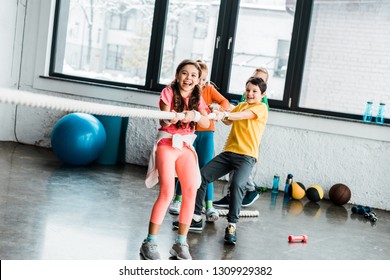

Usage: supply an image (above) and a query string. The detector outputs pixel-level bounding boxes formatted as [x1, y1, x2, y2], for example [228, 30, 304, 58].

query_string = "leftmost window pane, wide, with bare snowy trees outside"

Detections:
[54, 0, 155, 85]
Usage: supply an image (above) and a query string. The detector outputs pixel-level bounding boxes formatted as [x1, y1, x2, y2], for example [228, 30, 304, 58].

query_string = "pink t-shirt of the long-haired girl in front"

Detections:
[158, 87, 207, 145]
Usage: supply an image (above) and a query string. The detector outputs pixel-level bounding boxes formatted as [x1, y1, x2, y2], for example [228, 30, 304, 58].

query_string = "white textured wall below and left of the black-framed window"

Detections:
[0, 0, 390, 210]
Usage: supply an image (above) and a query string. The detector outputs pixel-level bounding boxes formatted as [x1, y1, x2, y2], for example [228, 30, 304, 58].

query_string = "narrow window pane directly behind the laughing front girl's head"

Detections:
[159, 0, 220, 84]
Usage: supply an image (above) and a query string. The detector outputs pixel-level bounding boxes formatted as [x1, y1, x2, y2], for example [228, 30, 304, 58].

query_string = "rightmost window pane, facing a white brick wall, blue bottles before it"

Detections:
[299, 0, 390, 115]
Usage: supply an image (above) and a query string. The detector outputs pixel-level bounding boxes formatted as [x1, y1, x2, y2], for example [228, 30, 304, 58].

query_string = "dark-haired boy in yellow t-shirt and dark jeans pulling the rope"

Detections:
[192, 77, 268, 244]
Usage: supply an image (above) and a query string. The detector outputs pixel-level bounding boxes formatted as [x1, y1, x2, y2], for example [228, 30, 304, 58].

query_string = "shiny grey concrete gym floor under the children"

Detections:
[0, 142, 390, 260]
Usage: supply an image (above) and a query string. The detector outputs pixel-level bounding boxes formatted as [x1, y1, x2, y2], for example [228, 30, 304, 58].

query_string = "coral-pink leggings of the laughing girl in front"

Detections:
[150, 145, 199, 225]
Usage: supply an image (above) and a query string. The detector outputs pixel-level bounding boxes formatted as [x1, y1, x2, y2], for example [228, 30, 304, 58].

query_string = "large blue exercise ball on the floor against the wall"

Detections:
[51, 113, 107, 165]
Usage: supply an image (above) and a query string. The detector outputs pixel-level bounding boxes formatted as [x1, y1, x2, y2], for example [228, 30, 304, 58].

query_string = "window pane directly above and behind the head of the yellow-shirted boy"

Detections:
[229, 0, 295, 100]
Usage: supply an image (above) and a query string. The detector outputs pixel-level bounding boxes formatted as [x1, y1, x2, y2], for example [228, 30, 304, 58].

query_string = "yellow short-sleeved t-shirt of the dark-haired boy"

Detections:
[224, 102, 268, 160]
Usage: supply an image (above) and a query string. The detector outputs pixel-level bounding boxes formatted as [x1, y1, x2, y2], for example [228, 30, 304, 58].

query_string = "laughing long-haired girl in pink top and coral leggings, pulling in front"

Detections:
[140, 59, 210, 260]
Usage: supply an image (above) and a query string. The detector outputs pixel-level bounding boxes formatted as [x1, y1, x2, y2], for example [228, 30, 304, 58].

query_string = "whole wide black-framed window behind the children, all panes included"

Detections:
[50, 0, 390, 122]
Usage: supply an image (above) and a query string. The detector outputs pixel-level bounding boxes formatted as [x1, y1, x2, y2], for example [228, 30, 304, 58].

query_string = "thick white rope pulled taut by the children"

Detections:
[0, 88, 215, 120]
